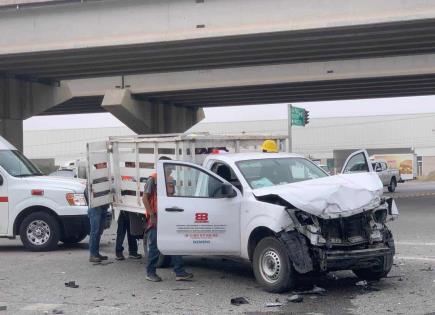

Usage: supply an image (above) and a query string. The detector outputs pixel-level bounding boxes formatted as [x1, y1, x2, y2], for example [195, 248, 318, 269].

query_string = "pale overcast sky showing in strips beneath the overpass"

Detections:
[24, 96, 435, 130]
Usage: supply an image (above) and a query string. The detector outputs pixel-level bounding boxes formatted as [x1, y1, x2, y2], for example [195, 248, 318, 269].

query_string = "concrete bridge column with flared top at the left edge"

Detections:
[0, 78, 72, 151]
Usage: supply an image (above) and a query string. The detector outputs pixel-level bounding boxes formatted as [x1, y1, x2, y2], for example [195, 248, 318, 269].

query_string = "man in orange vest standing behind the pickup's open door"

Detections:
[142, 157, 193, 282]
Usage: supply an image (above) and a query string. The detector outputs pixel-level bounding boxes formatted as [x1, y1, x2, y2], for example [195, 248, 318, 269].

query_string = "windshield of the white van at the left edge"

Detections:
[0, 150, 43, 177]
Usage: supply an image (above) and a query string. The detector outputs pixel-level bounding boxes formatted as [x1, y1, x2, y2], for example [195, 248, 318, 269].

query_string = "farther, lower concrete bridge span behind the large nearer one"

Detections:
[43, 54, 435, 115]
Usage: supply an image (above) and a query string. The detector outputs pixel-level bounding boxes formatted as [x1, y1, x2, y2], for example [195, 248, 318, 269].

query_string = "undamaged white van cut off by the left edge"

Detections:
[0, 137, 109, 251]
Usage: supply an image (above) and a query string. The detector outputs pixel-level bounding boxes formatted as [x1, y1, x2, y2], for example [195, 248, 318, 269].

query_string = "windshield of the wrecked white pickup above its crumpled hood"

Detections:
[236, 158, 328, 189]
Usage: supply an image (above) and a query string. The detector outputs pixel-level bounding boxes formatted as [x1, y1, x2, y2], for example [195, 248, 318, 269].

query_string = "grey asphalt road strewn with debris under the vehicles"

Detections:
[0, 183, 435, 315]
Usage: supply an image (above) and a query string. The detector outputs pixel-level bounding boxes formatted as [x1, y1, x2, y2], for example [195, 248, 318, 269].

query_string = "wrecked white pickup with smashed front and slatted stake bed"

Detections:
[88, 136, 398, 292]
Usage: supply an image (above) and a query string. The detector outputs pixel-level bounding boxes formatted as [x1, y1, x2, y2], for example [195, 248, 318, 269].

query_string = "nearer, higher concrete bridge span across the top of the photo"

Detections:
[0, 0, 435, 80]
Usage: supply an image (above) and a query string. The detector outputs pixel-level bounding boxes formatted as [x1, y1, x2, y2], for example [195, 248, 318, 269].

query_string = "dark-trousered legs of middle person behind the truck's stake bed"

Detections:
[115, 211, 142, 260]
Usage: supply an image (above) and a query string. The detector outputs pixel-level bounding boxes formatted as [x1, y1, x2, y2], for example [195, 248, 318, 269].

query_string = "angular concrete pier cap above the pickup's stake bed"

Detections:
[101, 89, 204, 134]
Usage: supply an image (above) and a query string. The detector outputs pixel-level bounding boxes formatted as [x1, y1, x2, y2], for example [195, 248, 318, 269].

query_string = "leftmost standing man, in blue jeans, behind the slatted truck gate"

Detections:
[84, 163, 109, 263]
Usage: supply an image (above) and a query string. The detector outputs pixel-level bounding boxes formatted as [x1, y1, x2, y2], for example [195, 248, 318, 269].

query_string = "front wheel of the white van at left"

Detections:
[20, 212, 60, 252]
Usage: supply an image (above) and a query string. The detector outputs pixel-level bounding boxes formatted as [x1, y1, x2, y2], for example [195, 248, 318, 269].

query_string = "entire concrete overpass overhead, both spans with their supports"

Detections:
[0, 0, 435, 149]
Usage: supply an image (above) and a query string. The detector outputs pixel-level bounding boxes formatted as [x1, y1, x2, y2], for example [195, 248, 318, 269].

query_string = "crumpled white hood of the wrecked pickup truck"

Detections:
[253, 173, 383, 218]
